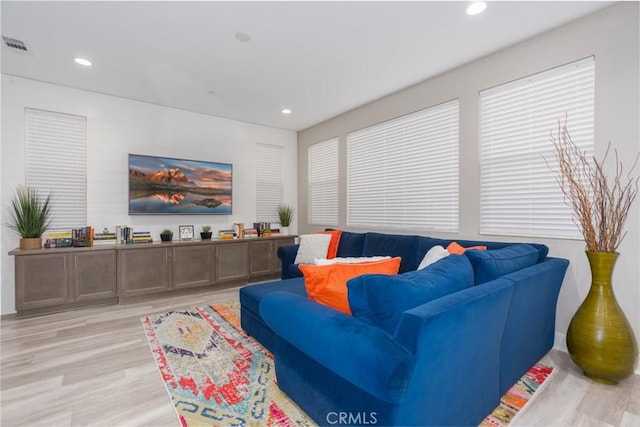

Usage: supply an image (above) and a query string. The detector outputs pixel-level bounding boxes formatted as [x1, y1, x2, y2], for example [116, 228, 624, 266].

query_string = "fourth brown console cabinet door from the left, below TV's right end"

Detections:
[173, 245, 211, 289]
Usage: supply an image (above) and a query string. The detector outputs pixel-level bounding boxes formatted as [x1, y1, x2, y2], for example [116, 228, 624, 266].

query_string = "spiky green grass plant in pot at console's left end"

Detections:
[7, 186, 53, 249]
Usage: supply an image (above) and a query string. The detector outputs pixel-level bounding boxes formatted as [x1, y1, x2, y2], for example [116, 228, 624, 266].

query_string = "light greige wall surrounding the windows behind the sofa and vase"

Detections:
[298, 2, 640, 368]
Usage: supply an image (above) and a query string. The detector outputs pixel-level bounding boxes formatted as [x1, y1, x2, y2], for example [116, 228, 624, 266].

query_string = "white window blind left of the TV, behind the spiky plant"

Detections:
[25, 108, 87, 231]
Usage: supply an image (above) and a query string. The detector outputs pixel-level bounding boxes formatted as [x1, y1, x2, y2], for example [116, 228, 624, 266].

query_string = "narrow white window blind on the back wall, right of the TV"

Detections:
[256, 143, 284, 222]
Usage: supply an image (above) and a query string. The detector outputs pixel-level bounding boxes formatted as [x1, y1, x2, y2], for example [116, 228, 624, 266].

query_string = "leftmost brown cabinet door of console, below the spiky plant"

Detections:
[15, 253, 70, 311]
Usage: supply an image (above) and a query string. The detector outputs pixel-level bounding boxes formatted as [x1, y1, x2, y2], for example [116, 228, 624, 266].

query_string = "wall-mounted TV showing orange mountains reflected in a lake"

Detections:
[129, 154, 233, 215]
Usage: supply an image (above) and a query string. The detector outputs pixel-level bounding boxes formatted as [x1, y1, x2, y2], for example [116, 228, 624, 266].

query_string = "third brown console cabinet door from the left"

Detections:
[118, 247, 171, 297]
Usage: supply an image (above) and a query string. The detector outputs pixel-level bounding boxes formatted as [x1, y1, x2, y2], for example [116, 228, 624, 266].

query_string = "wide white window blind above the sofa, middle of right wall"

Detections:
[347, 100, 459, 232]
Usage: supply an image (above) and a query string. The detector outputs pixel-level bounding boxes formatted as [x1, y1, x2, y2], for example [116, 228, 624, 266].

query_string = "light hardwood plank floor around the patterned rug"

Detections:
[0, 288, 640, 427]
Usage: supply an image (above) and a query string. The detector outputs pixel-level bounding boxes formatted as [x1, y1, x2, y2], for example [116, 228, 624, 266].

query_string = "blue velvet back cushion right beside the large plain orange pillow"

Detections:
[347, 255, 473, 334]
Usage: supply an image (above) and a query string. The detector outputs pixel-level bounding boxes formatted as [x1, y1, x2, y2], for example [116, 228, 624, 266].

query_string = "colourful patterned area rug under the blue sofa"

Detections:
[142, 302, 552, 427]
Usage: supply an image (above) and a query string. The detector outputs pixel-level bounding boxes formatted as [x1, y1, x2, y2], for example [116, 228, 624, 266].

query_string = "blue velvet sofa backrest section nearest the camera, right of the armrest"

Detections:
[394, 279, 513, 425]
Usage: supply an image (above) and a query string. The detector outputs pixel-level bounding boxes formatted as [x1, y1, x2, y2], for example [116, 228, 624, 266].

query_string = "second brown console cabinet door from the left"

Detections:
[70, 250, 117, 302]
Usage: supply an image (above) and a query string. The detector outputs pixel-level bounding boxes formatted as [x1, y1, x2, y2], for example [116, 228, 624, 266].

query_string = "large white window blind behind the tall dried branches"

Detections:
[480, 57, 595, 238]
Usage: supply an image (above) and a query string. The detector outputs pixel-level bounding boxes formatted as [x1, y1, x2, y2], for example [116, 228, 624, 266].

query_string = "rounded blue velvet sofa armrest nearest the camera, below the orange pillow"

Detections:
[260, 292, 413, 403]
